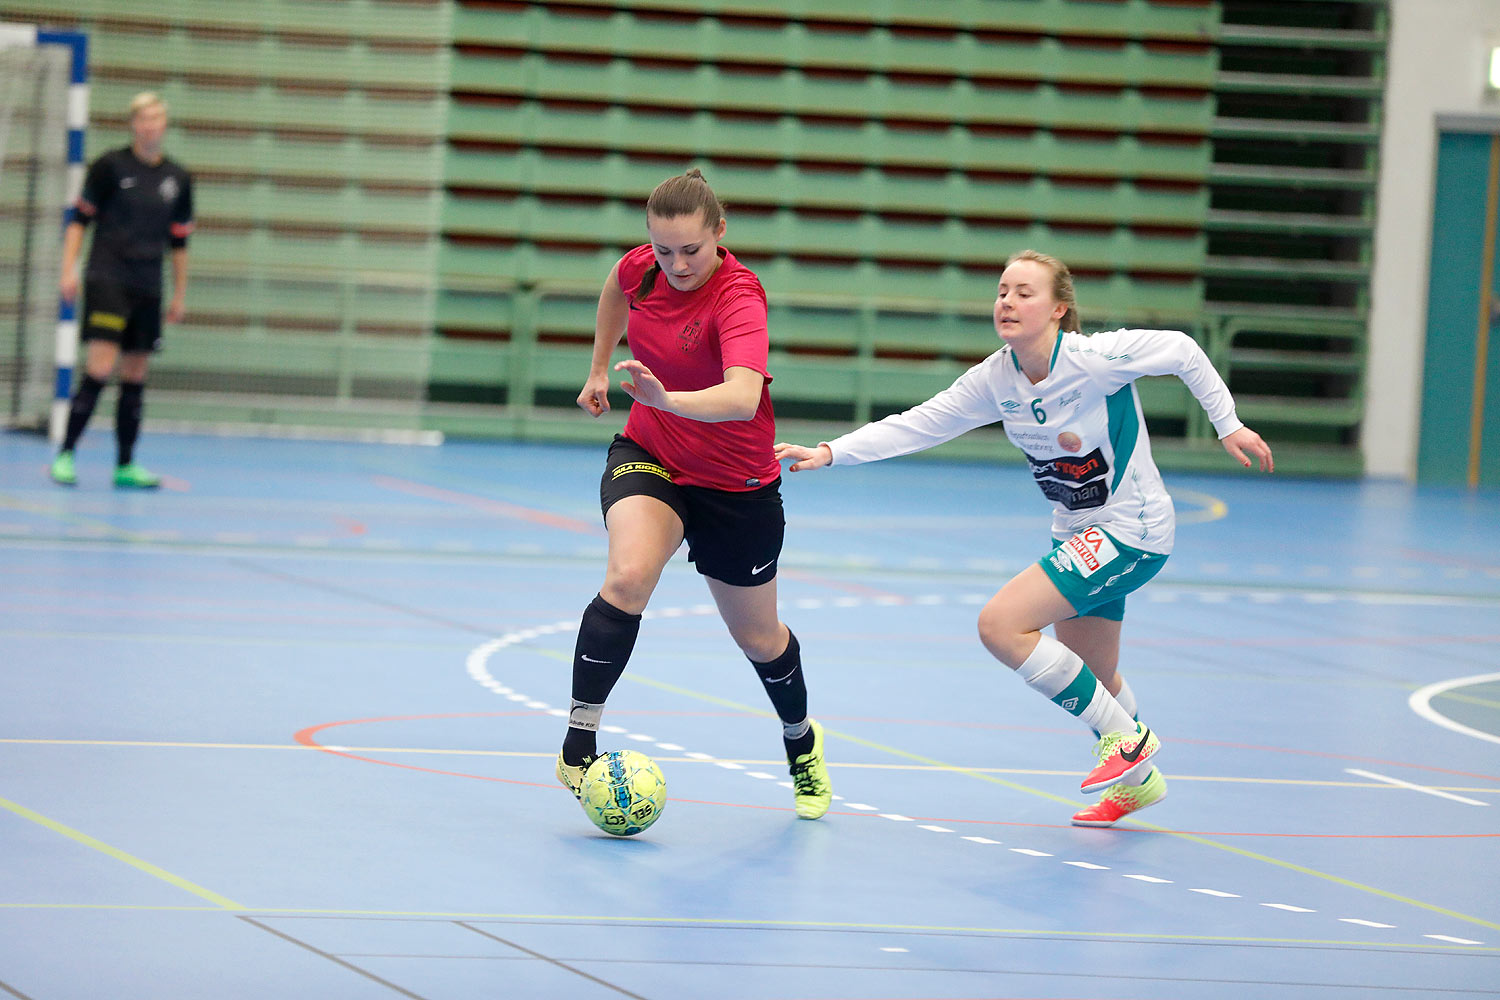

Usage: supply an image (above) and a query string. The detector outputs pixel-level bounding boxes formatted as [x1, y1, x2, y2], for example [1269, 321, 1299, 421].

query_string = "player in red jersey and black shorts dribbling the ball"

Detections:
[557, 169, 833, 819]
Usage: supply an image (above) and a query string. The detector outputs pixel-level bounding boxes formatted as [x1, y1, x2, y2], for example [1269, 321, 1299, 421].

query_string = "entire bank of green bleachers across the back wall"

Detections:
[8, 0, 1385, 474]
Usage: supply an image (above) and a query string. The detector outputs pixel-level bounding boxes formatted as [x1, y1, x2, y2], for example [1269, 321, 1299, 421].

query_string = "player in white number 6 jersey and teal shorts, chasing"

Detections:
[776, 250, 1274, 826]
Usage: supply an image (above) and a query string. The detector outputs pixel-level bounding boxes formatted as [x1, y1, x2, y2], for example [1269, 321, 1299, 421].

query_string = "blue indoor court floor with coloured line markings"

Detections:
[0, 430, 1500, 1000]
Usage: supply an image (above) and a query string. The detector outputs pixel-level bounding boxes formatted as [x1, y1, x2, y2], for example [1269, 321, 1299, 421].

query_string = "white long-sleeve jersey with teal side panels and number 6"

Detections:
[825, 330, 1244, 555]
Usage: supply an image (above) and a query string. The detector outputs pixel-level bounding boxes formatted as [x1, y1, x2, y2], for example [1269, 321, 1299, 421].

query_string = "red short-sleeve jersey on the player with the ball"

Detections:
[618, 243, 782, 492]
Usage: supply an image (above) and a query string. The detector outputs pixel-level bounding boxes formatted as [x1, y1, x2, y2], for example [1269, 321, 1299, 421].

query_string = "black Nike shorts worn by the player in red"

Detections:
[599, 435, 786, 586]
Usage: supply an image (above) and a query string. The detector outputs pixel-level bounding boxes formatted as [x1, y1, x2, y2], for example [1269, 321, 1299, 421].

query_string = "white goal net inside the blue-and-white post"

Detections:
[0, 25, 72, 429]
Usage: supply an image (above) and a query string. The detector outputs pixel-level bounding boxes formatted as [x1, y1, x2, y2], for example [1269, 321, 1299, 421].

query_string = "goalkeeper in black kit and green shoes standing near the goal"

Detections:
[53, 93, 194, 489]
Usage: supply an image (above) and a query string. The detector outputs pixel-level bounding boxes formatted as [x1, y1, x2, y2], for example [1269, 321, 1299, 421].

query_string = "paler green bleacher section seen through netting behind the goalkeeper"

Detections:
[6, 0, 450, 427]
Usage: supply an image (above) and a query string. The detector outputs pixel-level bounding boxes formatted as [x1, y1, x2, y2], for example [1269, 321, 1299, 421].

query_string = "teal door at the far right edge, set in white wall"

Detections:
[1418, 120, 1500, 489]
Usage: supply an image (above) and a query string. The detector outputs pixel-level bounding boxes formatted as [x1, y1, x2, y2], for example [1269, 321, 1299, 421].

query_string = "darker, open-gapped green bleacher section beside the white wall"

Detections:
[1203, 0, 1389, 474]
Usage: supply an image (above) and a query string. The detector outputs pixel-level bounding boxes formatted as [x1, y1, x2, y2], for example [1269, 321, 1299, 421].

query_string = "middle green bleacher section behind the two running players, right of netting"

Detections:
[435, 0, 1215, 457]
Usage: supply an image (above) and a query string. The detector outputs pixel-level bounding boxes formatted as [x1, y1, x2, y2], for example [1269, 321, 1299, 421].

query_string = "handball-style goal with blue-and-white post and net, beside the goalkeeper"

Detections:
[0, 22, 89, 444]
